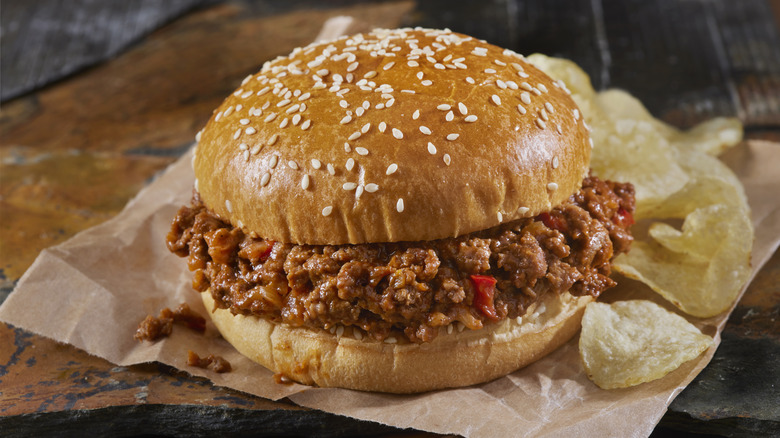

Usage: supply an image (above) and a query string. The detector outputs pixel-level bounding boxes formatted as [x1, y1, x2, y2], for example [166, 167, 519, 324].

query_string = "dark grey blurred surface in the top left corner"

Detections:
[0, 0, 213, 101]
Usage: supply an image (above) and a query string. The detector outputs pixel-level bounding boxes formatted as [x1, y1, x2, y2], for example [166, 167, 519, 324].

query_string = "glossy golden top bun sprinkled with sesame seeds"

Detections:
[193, 29, 591, 245]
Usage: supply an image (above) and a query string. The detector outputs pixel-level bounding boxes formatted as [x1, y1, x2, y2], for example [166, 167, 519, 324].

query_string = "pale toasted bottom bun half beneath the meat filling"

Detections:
[202, 291, 593, 393]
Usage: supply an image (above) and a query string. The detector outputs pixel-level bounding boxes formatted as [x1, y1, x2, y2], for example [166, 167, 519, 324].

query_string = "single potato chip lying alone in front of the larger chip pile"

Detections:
[580, 300, 713, 389]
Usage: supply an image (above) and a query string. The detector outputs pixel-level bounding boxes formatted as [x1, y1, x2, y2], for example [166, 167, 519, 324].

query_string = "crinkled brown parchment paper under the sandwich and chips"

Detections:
[0, 141, 780, 437]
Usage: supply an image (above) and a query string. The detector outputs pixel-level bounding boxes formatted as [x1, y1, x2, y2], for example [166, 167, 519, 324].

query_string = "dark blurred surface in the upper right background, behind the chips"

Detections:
[414, 0, 780, 127]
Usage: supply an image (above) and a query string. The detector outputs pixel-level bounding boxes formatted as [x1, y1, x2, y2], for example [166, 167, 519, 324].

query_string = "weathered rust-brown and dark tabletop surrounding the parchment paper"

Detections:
[0, 0, 780, 436]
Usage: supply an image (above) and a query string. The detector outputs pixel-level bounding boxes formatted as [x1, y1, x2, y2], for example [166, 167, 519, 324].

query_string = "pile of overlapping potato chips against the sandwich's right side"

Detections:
[529, 55, 753, 317]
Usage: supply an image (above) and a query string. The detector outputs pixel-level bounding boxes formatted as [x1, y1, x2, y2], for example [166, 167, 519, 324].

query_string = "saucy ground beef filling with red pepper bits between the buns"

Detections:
[167, 176, 634, 343]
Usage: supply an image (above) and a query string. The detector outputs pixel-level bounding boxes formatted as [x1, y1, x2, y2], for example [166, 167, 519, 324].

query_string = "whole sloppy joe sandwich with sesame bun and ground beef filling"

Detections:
[167, 29, 634, 393]
